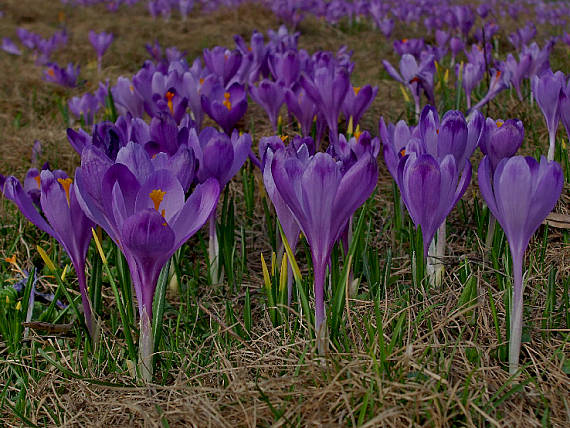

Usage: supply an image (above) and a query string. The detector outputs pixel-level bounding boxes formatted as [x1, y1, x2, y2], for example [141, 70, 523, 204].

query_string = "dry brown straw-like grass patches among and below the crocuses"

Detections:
[0, 0, 570, 427]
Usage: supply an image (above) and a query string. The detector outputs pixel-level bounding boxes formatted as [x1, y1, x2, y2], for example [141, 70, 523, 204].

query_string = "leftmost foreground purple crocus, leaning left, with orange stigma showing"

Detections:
[0, 170, 96, 337]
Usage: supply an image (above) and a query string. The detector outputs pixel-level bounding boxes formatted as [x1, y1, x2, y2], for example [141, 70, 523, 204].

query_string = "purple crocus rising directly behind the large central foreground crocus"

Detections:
[301, 67, 350, 144]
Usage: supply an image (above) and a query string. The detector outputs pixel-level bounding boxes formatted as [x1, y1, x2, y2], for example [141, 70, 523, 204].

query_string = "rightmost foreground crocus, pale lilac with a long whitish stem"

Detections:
[478, 156, 564, 374]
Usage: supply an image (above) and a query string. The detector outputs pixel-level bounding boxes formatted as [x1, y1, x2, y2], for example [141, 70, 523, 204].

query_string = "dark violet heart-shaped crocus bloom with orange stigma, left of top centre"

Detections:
[201, 83, 247, 135]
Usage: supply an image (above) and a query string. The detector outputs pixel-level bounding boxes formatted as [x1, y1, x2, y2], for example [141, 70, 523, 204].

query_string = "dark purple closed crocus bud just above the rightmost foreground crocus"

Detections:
[479, 118, 524, 172]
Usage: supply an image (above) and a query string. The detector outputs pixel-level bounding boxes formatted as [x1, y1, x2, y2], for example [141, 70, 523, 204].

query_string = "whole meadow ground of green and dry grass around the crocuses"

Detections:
[0, 0, 570, 427]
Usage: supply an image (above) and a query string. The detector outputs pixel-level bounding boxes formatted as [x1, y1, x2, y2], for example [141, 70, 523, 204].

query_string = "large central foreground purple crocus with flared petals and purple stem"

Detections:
[271, 150, 378, 353]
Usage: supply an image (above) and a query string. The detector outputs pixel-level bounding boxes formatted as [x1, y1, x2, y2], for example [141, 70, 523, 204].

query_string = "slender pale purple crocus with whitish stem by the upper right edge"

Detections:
[531, 70, 566, 161]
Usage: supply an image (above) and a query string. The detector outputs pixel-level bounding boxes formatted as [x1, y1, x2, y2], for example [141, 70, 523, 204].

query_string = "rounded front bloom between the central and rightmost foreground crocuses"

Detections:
[398, 152, 471, 258]
